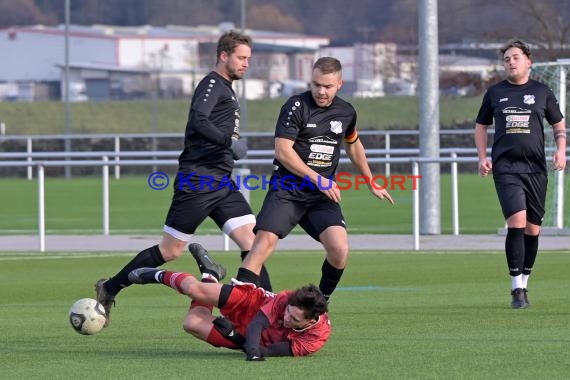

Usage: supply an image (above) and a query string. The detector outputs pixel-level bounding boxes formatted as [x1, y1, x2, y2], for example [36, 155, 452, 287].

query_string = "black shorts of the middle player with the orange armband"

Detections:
[254, 189, 346, 242]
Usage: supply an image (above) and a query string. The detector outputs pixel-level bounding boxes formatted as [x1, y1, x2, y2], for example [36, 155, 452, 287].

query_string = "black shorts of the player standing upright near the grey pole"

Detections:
[493, 173, 548, 226]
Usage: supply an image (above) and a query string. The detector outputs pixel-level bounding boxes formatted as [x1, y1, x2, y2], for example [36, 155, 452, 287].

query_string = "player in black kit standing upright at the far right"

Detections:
[475, 40, 566, 309]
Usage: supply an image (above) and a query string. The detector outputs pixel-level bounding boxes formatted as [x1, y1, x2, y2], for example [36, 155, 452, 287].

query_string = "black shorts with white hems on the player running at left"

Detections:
[164, 178, 255, 241]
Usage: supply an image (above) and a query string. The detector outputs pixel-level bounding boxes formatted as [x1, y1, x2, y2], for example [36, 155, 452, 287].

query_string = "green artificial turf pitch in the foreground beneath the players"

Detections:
[0, 252, 570, 380]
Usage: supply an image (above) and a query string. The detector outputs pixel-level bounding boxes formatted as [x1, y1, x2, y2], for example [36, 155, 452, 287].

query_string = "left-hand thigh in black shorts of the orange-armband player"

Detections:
[254, 189, 306, 239]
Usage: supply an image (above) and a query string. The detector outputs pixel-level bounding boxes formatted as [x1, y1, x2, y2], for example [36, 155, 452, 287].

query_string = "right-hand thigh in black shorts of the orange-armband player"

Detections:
[299, 198, 346, 242]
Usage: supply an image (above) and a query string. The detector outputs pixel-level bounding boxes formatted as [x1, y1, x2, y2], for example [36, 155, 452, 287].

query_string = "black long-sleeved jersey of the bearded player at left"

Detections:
[178, 71, 240, 178]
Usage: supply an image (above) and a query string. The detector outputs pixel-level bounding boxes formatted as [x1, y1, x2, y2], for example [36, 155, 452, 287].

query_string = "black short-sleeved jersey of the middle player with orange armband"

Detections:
[273, 91, 356, 189]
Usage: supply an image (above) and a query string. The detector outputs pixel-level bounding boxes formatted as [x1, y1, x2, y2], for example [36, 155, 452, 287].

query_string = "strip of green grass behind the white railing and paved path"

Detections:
[0, 174, 503, 234]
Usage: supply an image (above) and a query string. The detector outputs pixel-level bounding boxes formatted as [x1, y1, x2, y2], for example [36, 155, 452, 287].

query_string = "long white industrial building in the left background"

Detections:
[0, 23, 329, 101]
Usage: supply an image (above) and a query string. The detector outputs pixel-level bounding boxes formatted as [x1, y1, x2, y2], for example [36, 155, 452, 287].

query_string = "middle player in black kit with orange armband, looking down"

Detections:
[234, 57, 393, 299]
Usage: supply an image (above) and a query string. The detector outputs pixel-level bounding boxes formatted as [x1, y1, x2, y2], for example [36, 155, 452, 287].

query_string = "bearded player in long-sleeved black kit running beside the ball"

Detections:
[95, 31, 271, 325]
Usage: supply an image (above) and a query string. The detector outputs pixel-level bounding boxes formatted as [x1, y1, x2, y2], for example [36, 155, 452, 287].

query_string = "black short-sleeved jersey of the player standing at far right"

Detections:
[477, 79, 563, 174]
